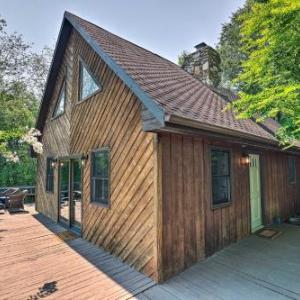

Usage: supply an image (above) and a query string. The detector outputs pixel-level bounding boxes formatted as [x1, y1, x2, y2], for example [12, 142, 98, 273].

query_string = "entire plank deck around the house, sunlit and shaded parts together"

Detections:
[0, 205, 300, 300]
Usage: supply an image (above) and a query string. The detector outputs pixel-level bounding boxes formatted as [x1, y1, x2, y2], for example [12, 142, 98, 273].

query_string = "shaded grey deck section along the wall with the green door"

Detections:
[135, 225, 300, 300]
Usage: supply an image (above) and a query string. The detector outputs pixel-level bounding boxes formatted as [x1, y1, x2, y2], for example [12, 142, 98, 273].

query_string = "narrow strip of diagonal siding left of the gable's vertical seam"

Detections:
[36, 36, 74, 220]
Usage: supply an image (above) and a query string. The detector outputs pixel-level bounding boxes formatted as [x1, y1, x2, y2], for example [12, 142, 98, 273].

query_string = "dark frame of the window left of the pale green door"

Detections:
[209, 146, 233, 209]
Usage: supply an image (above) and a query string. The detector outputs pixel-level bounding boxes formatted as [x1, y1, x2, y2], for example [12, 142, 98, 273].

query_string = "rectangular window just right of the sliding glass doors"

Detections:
[91, 148, 109, 205]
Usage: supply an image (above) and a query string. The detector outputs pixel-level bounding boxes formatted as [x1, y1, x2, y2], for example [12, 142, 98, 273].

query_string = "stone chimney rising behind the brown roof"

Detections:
[183, 43, 221, 87]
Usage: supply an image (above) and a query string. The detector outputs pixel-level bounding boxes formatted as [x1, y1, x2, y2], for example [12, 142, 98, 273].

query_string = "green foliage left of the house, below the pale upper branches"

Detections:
[0, 85, 38, 186]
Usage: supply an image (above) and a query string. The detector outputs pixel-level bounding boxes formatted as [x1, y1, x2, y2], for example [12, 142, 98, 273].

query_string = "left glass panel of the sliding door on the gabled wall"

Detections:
[59, 160, 70, 225]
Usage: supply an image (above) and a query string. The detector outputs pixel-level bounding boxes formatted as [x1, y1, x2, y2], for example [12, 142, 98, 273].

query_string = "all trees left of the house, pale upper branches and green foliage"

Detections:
[0, 18, 52, 186]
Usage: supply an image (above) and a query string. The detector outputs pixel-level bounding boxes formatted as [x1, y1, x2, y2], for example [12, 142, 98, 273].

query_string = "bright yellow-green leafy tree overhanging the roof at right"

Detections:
[232, 0, 300, 144]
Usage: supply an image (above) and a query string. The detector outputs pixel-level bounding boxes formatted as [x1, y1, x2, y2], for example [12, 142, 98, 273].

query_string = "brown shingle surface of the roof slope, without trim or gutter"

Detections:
[66, 13, 275, 141]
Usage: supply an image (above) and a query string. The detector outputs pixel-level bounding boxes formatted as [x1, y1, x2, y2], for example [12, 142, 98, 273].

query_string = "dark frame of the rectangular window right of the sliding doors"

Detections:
[90, 146, 110, 208]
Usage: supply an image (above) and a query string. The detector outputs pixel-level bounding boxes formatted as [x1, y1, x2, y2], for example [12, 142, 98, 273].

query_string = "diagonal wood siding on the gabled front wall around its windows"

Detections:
[37, 32, 156, 278]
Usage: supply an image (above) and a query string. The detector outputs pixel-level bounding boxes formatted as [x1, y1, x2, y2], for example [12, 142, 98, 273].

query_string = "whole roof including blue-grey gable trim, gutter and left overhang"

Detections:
[35, 11, 296, 149]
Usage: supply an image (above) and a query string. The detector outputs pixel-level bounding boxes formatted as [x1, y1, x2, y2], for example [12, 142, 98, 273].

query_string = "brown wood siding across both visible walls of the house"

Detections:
[36, 26, 300, 281]
